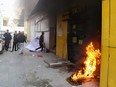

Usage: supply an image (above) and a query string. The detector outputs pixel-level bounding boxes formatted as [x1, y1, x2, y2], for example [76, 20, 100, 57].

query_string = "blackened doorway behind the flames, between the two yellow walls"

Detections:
[67, 0, 101, 65]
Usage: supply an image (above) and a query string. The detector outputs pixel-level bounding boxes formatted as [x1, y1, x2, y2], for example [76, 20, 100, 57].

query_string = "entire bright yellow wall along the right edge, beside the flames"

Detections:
[100, 0, 116, 87]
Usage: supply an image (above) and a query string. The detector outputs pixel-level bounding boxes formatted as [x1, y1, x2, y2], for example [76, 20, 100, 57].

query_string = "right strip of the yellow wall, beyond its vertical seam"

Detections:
[108, 0, 116, 87]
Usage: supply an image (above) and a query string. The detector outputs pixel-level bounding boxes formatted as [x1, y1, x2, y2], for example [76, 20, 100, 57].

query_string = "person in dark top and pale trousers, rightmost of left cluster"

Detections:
[18, 32, 26, 54]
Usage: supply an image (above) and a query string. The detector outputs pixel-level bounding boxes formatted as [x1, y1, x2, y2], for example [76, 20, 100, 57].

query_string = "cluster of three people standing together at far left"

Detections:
[3, 30, 26, 54]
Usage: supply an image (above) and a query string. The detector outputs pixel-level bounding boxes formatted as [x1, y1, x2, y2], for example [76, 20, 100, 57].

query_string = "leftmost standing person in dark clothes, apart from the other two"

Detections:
[3, 30, 12, 51]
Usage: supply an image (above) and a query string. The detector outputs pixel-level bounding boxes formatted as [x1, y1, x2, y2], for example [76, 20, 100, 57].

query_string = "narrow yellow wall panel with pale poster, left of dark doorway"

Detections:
[56, 15, 67, 60]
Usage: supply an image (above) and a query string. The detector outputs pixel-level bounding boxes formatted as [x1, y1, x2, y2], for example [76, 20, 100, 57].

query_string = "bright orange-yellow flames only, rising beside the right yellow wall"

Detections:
[71, 42, 101, 82]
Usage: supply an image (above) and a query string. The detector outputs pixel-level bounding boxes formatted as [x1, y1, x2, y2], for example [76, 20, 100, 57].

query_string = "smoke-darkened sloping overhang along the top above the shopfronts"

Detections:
[31, 0, 101, 15]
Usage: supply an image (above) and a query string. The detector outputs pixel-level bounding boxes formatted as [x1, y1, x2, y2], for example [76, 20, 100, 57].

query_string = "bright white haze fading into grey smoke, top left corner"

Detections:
[0, 0, 39, 23]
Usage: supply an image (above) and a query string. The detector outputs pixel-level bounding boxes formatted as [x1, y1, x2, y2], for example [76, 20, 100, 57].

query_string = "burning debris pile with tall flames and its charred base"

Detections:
[67, 42, 101, 85]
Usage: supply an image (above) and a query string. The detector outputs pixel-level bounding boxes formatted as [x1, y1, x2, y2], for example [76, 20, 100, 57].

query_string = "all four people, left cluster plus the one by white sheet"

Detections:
[3, 30, 45, 54]
